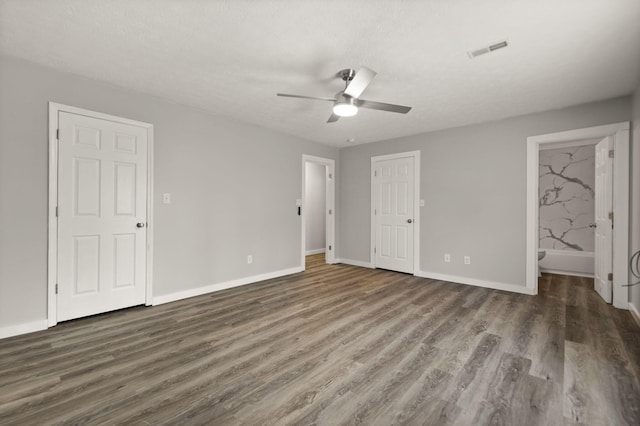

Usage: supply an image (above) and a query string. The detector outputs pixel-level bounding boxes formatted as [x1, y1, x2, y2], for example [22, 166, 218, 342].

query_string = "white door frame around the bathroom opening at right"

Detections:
[526, 121, 630, 309]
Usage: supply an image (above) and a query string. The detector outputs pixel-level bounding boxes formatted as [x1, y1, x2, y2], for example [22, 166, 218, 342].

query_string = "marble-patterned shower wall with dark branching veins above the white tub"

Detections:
[539, 145, 595, 252]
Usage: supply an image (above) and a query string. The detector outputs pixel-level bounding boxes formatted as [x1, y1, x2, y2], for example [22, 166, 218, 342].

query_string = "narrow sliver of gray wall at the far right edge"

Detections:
[629, 82, 640, 310]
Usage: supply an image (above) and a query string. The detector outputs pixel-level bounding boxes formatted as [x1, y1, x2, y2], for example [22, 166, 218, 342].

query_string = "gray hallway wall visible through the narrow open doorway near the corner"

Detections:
[305, 162, 327, 251]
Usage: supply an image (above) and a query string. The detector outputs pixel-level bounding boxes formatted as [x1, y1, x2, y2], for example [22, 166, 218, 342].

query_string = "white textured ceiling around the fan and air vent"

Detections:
[0, 0, 640, 146]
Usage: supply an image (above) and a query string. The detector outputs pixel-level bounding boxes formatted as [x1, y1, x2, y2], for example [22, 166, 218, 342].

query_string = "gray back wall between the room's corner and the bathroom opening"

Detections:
[340, 97, 631, 286]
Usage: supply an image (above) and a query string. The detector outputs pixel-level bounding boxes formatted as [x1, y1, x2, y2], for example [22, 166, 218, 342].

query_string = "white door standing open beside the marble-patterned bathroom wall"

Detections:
[594, 136, 613, 303]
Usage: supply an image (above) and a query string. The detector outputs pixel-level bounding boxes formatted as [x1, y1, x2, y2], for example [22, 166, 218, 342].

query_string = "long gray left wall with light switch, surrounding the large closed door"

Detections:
[0, 57, 339, 328]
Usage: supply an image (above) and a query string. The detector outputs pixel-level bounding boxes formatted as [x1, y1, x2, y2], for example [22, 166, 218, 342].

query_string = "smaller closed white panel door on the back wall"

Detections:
[374, 157, 415, 273]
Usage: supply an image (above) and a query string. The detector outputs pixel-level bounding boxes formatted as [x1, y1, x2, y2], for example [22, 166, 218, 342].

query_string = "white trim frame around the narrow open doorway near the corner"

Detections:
[300, 154, 336, 271]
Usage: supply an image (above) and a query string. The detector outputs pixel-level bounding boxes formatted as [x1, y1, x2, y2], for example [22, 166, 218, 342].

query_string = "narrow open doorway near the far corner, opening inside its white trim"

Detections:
[301, 155, 335, 268]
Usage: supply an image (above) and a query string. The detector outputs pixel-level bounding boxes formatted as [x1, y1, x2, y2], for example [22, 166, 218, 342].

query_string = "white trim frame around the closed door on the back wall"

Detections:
[369, 151, 420, 275]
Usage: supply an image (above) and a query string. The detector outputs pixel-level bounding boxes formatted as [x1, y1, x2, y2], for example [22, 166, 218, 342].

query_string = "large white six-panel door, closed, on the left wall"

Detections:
[57, 112, 148, 321]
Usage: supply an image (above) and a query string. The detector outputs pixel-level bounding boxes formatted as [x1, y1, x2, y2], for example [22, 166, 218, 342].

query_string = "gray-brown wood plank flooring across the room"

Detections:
[0, 255, 640, 425]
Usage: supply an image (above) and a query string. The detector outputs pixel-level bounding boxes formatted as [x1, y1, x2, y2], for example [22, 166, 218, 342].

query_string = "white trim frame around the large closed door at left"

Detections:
[47, 102, 154, 327]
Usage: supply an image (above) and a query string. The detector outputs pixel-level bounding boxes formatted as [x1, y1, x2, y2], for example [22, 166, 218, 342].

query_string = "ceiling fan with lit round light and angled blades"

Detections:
[278, 67, 411, 123]
